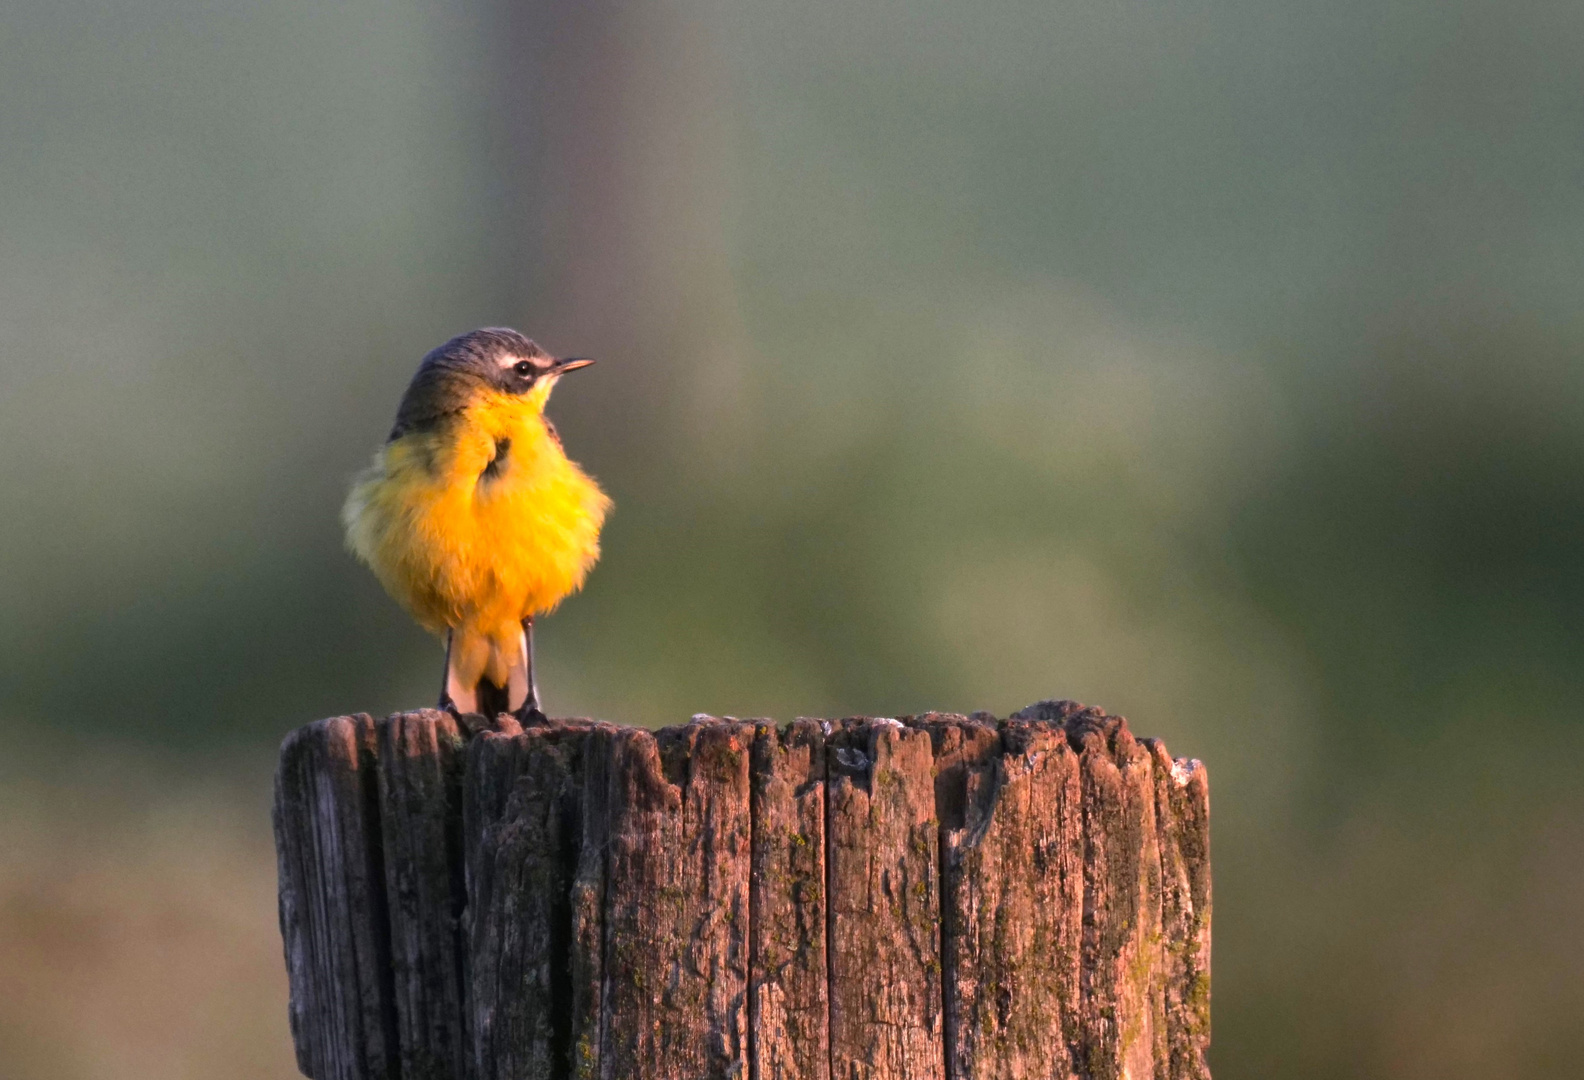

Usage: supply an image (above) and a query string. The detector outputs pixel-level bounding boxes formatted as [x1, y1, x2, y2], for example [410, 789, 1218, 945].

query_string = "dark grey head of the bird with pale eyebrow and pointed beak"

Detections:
[390, 326, 594, 439]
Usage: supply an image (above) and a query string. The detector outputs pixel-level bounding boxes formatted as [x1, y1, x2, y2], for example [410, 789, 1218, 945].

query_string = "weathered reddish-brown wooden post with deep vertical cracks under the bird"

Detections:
[276, 702, 1210, 1080]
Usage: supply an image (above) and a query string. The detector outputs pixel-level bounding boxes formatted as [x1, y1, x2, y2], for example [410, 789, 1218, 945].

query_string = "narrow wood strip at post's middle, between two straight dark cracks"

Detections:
[748, 719, 830, 1080]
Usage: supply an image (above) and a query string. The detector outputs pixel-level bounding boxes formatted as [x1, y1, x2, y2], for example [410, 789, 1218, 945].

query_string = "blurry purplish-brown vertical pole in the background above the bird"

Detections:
[489, 0, 744, 475]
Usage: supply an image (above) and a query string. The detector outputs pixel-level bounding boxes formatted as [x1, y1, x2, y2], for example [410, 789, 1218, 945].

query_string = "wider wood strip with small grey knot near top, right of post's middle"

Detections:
[825, 721, 946, 1080]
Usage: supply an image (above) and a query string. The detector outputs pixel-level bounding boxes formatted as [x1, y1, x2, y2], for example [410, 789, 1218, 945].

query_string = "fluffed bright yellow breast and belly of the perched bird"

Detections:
[342, 386, 610, 641]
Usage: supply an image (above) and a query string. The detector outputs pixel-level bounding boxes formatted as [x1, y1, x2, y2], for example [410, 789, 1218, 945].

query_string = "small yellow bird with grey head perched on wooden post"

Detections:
[341, 328, 611, 714]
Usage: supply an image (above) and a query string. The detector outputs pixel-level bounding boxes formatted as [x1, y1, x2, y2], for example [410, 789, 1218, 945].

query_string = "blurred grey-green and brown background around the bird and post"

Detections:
[0, 0, 1584, 1080]
